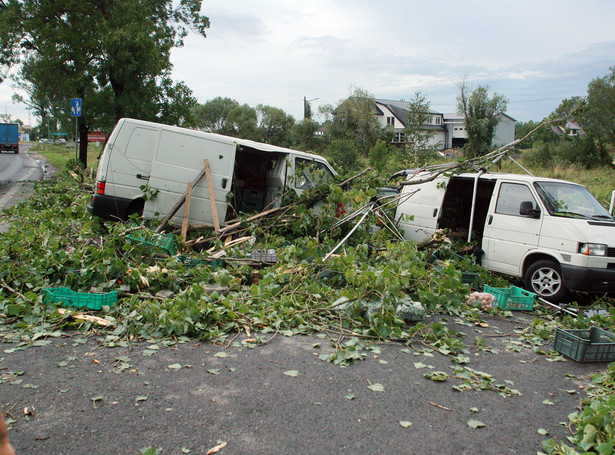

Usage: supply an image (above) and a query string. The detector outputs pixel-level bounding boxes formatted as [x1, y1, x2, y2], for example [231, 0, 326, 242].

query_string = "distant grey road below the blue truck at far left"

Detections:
[0, 144, 45, 214]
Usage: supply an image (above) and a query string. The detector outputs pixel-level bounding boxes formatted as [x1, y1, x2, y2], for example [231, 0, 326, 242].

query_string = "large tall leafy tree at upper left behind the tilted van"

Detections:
[0, 0, 209, 164]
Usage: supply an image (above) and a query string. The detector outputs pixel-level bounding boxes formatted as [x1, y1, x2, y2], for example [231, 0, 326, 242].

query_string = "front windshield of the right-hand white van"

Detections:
[534, 182, 615, 221]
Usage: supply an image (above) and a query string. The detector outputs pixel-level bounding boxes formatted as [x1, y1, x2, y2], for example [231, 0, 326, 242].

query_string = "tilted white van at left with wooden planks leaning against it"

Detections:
[88, 118, 335, 226]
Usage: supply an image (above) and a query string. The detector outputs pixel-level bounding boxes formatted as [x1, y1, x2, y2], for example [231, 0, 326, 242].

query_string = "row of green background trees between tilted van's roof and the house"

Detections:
[191, 89, 416, 175]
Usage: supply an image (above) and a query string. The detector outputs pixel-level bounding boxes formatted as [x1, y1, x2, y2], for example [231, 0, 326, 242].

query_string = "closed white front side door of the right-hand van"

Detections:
[482, 181, 543, 276]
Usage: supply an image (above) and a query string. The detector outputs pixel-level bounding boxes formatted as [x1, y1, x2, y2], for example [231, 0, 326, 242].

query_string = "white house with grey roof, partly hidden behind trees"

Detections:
[374, 99, 516, 150]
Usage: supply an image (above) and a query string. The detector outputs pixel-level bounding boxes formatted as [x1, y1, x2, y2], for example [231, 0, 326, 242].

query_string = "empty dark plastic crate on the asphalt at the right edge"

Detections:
[553, 327, 615, 362]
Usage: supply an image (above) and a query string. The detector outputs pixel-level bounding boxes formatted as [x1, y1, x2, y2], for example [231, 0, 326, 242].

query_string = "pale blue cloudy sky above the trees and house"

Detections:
[0, 0, 615, 123]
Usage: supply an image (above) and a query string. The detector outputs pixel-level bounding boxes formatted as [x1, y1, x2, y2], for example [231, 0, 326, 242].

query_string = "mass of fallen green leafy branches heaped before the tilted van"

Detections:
[0, 171, 482, 346]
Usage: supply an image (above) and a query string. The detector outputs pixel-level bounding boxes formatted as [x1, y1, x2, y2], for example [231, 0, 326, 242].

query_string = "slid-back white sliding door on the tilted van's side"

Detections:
[143, 129, 236, 226]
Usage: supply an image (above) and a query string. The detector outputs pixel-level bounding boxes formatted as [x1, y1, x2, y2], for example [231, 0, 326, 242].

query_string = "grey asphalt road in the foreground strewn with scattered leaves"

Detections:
[0, 314, 606, 455]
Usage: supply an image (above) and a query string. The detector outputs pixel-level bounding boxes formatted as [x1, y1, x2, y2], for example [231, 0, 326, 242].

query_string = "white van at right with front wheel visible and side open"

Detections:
[396, 172, 615, 302]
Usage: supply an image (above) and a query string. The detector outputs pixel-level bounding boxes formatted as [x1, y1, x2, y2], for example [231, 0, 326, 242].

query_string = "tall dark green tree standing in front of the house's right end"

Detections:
[457, 80, 508, 158]
